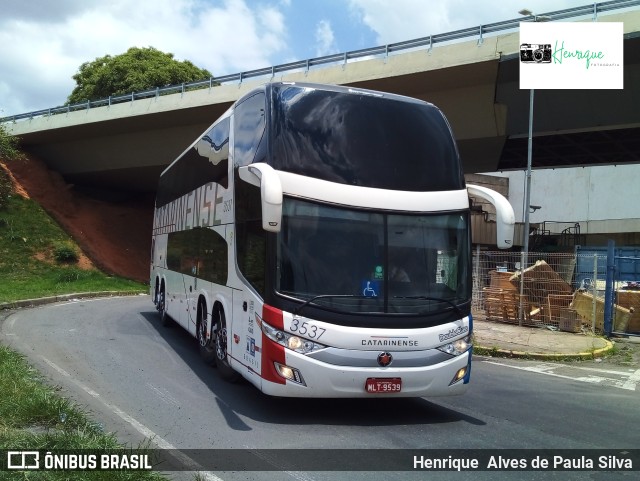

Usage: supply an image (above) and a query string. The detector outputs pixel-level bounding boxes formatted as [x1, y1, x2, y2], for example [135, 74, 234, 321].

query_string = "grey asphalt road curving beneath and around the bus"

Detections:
[0, 296, 640, 481]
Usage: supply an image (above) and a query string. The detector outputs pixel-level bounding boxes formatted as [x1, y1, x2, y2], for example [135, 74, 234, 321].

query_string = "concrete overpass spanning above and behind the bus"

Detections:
[7, 10, 640, 191]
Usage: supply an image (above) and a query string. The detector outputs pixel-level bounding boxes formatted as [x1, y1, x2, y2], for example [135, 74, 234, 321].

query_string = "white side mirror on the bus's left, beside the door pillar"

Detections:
[238, 162, 282, 232]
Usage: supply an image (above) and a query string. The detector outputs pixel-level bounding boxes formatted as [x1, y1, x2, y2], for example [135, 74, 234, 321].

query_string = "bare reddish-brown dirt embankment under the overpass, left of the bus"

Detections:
[6, 158, 153, 282]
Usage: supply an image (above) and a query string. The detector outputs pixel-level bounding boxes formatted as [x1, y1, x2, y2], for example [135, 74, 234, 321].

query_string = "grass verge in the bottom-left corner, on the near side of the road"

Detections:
[0, 345, 166, 481]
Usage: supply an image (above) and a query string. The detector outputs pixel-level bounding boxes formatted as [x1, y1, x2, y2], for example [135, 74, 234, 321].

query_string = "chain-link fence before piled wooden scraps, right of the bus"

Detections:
[472, 251, 640, 333]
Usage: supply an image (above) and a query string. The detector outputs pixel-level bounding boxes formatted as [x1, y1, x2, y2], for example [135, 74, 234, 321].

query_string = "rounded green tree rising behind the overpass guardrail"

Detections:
[67, 47, 212, 104]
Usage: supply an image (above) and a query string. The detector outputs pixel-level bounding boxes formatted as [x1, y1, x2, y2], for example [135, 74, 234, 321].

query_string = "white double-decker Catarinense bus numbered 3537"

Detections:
[150, 83, 514, 397]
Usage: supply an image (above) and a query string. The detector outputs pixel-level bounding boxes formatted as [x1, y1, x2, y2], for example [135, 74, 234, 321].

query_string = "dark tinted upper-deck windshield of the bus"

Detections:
[269, 85, 464, 192]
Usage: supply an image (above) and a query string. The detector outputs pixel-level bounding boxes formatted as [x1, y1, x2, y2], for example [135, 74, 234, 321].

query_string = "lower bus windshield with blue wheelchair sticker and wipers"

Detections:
[275, 197, 471, 315]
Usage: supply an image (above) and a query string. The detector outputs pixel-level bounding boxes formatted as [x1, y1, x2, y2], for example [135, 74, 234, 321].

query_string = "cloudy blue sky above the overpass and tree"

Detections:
[0, 0, 616, 117]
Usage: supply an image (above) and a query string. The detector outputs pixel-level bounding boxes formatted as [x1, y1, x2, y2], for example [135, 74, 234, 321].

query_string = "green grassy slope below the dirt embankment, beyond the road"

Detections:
[0, 195, 148, 303]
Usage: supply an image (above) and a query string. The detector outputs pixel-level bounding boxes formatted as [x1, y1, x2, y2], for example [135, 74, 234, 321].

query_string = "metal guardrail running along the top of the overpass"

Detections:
[0, 0, 640, 123]
